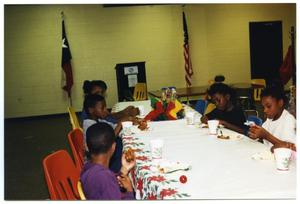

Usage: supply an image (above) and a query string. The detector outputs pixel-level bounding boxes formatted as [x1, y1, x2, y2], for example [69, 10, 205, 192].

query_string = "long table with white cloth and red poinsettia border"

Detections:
[122, 115, 296, 199]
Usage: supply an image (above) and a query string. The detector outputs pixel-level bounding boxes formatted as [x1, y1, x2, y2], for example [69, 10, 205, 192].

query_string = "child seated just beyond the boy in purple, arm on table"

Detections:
[83, 94, 135, 172]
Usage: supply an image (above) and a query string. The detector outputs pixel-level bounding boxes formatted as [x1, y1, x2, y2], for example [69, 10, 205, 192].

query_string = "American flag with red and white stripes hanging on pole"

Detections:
[182, 12, 194, 86]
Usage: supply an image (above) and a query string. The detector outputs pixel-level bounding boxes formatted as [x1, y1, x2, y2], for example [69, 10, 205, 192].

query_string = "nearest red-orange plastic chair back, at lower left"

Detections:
[43, 150, 80, 200]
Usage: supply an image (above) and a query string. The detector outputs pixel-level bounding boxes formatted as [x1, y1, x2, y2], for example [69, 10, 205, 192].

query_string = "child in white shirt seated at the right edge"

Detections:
[249, 86, 296, 152]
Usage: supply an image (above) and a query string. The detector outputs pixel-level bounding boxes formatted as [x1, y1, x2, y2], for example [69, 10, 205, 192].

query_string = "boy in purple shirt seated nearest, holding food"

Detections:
[80, 122, 135, 200]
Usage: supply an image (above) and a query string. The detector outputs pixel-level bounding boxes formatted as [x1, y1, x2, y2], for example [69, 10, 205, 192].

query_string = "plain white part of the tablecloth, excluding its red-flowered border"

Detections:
[135, 120, 296, 199]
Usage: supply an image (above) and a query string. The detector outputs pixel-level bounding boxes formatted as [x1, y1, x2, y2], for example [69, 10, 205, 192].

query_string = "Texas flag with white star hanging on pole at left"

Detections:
[61, 20, 73, 98]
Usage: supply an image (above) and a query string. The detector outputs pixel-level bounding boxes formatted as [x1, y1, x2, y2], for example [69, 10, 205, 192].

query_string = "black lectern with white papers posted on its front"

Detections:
[115, 62, 147, 102]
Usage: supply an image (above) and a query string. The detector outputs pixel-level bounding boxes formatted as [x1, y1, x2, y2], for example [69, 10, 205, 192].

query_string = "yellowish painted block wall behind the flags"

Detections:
[4, 4, 296, 118]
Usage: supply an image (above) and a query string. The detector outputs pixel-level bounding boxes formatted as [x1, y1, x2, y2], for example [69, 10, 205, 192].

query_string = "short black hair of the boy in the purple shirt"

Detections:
[86, 122, 116, 157]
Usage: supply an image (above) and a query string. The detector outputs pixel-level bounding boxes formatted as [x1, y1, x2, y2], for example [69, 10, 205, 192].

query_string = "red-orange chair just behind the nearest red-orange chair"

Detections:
[68, 128, 85, 171]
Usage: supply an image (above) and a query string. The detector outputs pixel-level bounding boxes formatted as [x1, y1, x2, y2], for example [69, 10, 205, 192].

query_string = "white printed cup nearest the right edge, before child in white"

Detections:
[274, 148, 292, 171]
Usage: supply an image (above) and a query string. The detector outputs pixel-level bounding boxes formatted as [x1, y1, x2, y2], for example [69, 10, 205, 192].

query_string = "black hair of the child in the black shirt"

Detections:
[207, 83, 236, 104]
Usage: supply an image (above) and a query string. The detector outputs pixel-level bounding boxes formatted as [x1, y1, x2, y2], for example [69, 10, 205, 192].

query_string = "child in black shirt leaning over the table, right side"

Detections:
[201, 83, 248, 134]
